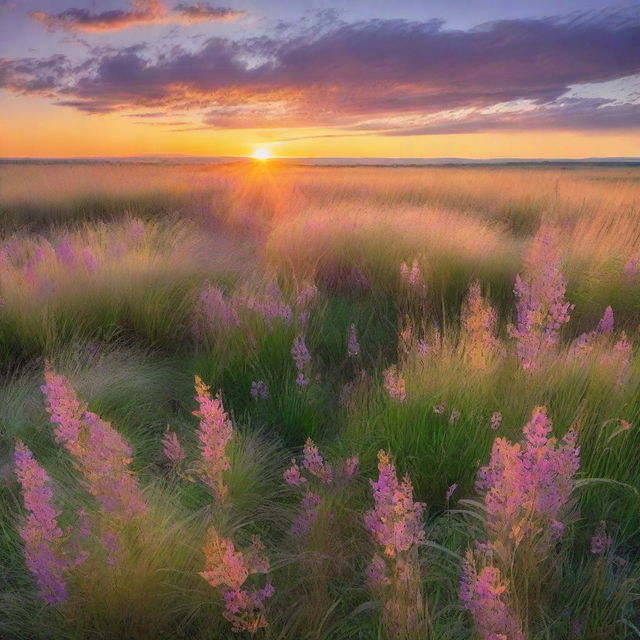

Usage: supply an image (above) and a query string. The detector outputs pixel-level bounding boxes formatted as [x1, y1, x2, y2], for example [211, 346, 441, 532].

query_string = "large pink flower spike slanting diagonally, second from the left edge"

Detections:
[42, 369, 147, 523]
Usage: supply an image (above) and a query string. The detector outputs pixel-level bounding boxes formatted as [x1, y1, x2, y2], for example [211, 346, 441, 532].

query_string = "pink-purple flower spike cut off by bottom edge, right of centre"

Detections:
[460, 550, 524, 640]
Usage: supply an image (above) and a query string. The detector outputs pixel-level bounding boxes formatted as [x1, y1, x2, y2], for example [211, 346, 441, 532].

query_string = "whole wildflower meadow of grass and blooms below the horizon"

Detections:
[0, 160, 640, 640]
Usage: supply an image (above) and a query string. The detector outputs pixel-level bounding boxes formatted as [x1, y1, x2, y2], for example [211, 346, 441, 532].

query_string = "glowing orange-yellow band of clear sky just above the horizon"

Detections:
[0, 94, 640, 158]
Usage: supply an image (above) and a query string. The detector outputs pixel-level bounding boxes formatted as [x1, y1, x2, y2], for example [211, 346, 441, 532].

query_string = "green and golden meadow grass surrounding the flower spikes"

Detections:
[0, 166, 640, 640]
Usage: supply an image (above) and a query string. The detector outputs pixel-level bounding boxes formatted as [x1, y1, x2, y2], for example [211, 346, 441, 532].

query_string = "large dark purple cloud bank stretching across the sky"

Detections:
[7, 8, 640, 135]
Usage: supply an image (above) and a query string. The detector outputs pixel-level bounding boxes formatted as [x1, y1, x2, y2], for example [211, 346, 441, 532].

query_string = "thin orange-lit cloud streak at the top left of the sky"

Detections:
[30, 0, 246, 32]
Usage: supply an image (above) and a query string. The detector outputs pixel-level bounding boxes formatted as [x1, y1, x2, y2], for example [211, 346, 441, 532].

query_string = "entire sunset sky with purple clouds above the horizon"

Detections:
[0, 0, 640, 158]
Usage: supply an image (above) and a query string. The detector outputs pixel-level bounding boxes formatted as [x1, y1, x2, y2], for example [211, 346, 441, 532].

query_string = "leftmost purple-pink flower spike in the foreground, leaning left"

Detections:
[15, 440, 69, 605]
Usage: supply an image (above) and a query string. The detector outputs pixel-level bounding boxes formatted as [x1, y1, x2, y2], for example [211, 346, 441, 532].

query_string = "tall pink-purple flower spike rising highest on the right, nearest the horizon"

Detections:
[508, 227, 573, 370]
